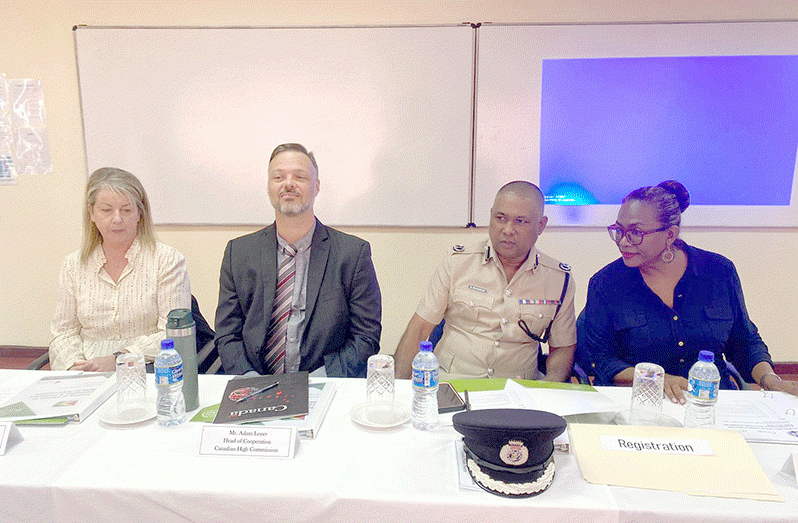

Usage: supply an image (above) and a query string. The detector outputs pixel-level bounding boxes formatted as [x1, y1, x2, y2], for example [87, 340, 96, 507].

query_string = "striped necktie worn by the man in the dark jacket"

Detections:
[264, 245, 296, 374]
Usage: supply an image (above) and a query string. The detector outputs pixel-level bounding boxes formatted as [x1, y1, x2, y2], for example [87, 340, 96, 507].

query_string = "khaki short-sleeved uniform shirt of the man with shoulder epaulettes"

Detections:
[416, 240, 576, 379]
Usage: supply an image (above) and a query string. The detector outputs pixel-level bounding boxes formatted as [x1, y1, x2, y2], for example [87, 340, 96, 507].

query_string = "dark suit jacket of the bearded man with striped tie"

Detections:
[216, 220, 382, 377]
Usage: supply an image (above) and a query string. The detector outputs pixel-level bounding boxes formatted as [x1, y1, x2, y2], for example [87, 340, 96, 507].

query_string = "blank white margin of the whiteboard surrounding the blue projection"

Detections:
[474, 20, 798, 228]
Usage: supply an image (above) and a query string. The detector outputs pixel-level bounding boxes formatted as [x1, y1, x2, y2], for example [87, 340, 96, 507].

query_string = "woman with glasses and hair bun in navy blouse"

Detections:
[584, 180, 798, 403]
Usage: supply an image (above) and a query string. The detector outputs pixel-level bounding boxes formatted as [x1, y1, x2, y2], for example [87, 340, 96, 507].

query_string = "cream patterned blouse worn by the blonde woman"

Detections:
[50, 238, 191, 370]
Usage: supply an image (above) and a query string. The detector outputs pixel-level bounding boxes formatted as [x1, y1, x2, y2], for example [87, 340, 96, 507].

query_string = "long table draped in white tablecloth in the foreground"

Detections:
[0, 370, 798, 523]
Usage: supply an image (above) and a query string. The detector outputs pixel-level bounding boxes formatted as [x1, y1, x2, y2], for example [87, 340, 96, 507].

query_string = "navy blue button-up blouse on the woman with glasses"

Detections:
[585, 245, 772, 388]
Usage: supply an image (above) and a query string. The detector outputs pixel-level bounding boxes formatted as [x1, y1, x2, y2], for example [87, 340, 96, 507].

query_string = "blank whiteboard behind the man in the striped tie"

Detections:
[74, 25, 474, 226]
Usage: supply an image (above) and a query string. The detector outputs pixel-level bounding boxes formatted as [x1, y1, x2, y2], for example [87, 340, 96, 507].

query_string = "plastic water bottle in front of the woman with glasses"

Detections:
[684, 350, 720, 427]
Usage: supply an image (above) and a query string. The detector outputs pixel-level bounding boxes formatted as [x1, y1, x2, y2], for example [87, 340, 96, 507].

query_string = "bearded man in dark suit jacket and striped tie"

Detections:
[216, 144, 382, 377]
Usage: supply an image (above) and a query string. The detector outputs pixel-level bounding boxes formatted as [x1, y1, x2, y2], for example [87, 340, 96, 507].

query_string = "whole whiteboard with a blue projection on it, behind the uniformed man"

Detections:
[474, 21, 798, 227]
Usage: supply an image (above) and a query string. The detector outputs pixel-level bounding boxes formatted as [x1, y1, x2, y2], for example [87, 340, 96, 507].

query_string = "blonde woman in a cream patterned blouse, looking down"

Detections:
[50, 167, 191, 371]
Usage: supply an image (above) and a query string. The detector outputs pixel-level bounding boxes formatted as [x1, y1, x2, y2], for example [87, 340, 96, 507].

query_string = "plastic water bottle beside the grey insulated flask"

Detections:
[155, 339, 186, 427]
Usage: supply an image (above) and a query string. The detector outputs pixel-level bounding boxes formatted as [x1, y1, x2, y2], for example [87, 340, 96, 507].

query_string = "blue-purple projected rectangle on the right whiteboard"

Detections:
[540, 56, 798, 205]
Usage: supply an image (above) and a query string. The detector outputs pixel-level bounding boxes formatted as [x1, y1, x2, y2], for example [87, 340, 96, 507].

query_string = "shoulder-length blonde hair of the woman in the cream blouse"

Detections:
[80, 167, 155, 263]
